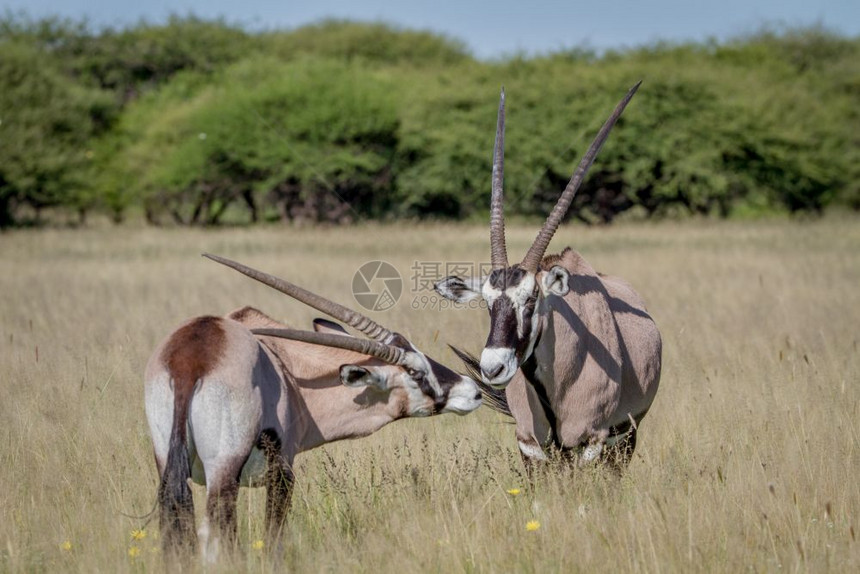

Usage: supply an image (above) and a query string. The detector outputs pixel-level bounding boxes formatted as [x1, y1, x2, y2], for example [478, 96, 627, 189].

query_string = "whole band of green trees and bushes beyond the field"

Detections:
[0, 14, 860, 227]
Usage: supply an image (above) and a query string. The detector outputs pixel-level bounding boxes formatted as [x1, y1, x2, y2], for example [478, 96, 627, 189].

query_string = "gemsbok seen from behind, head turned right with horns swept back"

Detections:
[145, 255, 481, 560]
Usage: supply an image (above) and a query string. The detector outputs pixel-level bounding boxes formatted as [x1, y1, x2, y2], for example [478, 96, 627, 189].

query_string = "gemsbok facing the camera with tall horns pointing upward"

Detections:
[436, 84, 662, 469]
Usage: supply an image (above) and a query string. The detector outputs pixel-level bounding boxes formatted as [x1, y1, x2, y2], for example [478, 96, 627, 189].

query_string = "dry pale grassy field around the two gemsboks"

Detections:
[0, 218, 860, 574]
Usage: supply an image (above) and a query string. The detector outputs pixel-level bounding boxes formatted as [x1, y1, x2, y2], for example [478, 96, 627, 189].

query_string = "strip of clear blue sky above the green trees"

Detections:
[6, 0, 860, 58]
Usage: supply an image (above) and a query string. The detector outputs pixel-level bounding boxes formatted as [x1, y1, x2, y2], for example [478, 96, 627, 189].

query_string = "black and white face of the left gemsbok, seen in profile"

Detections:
[341, 333, 482, 417]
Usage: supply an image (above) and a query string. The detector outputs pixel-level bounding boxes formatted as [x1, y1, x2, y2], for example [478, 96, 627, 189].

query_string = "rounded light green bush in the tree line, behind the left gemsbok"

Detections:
[107, 59, 397, 224]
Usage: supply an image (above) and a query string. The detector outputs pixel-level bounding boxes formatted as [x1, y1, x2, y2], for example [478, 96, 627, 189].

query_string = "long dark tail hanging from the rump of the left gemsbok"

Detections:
[158, 378, 196, 552]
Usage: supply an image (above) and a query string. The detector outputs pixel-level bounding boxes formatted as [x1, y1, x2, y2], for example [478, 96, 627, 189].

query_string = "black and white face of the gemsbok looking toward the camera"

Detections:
[481, 265, 540, 388]
